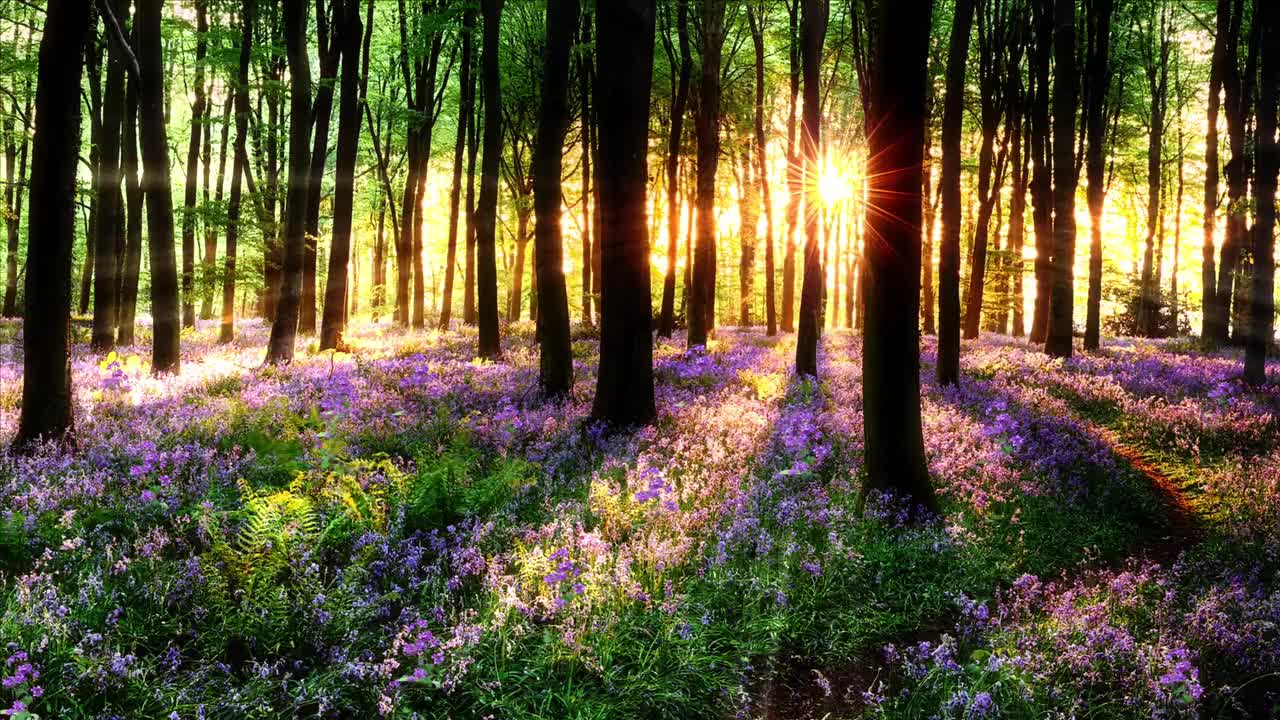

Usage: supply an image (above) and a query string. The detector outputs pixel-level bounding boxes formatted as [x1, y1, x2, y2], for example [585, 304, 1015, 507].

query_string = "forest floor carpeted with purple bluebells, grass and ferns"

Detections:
[0, 322, 1280, 720]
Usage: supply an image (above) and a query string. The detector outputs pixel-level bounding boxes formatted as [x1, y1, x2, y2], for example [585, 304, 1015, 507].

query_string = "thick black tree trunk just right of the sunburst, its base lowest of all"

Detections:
[863, 0, 938, 515]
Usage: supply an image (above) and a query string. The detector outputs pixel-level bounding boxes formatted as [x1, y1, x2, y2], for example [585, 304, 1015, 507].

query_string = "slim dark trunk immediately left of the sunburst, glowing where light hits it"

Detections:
[796, 0, 824, 377]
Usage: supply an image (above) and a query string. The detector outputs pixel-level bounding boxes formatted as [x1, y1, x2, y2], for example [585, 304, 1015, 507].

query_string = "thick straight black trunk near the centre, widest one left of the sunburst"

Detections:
[591, 0, 657, 427]
